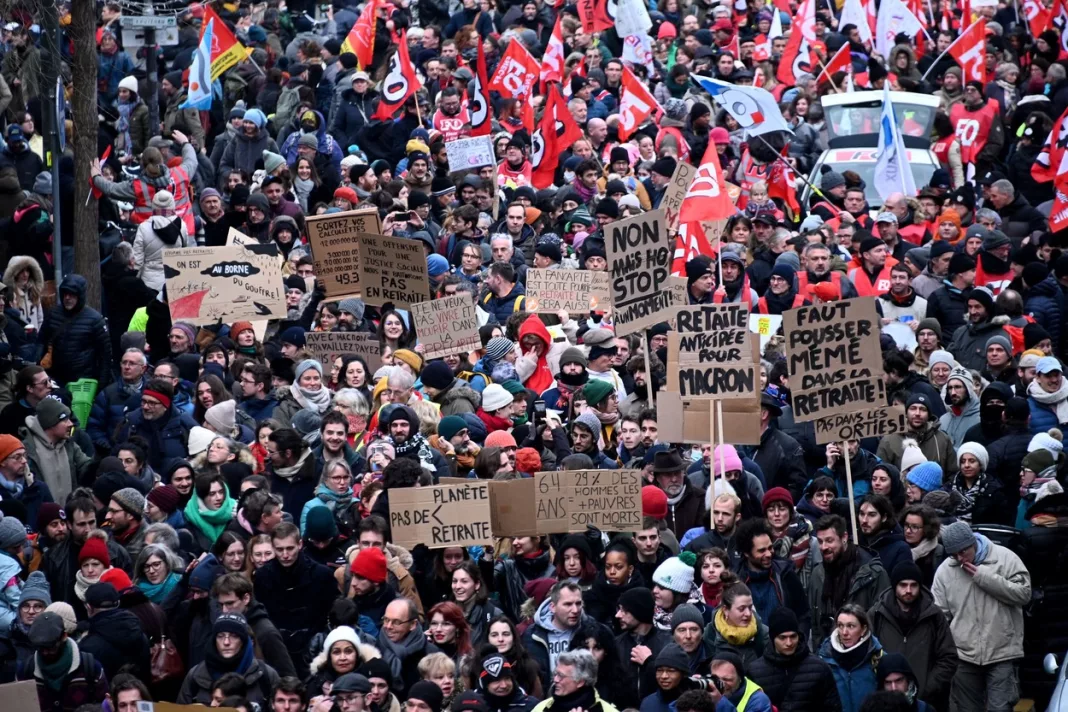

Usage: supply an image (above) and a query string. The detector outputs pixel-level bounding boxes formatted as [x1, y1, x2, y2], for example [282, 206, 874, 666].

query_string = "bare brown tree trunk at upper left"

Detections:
[67, 2, 100, 309]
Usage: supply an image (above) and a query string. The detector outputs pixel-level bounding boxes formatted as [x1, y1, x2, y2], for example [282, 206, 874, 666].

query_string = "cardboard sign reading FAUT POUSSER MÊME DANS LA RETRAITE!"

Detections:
[783, 297, 886, 423]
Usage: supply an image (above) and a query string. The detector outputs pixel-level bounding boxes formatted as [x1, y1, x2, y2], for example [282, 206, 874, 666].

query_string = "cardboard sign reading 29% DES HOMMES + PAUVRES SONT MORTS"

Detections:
[534, 470, 642, 534]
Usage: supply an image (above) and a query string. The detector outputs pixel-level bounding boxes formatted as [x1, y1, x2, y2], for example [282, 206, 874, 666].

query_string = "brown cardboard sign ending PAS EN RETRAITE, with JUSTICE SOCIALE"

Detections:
[360, 235, 430, 310]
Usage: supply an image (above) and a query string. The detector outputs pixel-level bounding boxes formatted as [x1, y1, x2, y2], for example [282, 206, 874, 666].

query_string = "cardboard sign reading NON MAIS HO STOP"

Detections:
[604, 210, 675, 336]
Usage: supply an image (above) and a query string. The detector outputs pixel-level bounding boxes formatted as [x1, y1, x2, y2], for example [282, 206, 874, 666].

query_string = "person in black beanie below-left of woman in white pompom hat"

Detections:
[615, 587, 666, 699]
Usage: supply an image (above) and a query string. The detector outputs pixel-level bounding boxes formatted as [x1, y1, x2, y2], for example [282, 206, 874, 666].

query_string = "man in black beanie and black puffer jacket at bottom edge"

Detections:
[745, 608, 842, 712]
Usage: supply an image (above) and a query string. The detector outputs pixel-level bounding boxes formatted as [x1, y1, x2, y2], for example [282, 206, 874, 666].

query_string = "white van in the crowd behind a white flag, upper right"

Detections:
[800, 92, 941, 212]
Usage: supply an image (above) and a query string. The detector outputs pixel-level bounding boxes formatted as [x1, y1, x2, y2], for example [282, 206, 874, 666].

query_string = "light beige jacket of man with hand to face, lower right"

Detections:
[931, 534, 1031, 665]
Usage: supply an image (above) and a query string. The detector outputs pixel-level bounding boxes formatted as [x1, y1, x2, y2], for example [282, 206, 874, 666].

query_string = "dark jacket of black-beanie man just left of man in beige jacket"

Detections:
[868, 587, 957, 700]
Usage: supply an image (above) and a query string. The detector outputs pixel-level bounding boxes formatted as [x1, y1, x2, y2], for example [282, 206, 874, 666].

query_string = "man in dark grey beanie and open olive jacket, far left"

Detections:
[19, 397, 91, 502]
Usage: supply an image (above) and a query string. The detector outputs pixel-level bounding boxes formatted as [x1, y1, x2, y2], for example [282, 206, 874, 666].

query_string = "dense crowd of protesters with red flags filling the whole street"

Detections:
[0, 0, 1068, 712]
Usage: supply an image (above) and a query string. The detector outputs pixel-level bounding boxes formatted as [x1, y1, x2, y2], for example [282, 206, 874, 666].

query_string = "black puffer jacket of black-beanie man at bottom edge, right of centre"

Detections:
[745, 634, 842, 712]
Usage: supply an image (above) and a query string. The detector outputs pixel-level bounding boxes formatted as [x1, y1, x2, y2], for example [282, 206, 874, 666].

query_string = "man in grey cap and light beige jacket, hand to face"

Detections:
[931, 521, 1031, 712]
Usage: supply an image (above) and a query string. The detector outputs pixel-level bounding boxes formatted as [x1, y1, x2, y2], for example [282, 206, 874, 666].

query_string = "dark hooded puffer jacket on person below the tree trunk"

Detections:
[37, 274, 111, 389]
